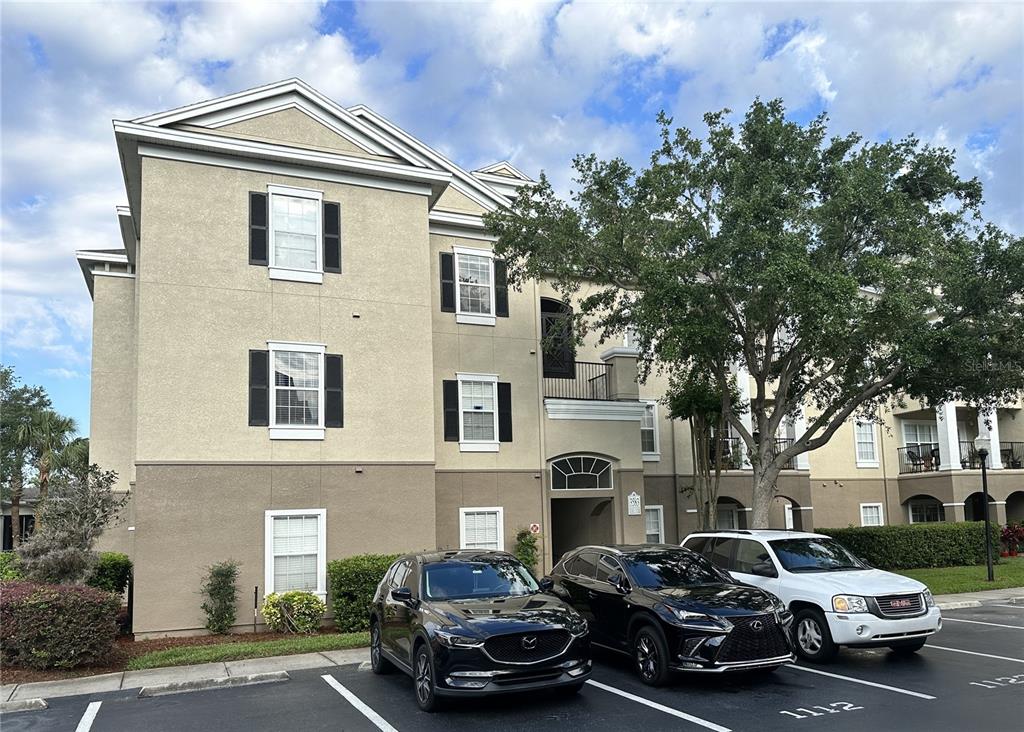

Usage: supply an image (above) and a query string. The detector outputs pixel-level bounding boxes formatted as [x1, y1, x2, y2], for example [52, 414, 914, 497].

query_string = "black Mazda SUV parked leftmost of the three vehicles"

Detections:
[370, 550, 591, 712]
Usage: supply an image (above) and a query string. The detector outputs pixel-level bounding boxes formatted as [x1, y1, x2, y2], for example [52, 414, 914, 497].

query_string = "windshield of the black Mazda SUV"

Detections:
[423, 557, 539, 600]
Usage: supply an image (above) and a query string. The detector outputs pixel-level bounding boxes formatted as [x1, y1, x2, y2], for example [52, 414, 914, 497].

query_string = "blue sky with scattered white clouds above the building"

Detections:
[0, 2, 1024, 434]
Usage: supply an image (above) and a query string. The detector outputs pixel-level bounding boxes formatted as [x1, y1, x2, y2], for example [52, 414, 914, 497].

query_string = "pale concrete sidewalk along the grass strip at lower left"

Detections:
[0, 648, 370, 712]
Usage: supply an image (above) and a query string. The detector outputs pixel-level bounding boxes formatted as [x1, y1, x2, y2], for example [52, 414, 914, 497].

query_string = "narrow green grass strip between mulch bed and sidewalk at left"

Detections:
[125, 633, 370, 671]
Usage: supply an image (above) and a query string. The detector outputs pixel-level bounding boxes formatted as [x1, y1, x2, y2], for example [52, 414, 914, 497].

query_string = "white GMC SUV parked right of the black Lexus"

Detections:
[682, 529, 942, 661]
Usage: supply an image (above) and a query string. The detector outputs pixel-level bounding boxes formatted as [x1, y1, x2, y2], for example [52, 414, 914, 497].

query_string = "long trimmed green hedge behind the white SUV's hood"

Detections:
[814, 521, 999, 569]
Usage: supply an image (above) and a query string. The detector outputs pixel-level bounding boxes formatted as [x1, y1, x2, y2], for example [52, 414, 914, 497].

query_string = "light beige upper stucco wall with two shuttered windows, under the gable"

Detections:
[137, 159, 435, 461]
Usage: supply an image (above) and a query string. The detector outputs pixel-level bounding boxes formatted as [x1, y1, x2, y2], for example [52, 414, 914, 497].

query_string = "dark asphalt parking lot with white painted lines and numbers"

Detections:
[2, 605, 1024, 732]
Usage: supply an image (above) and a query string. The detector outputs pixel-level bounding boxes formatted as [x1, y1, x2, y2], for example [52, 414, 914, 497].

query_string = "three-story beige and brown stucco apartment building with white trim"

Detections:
[78, 80, 1024, 636]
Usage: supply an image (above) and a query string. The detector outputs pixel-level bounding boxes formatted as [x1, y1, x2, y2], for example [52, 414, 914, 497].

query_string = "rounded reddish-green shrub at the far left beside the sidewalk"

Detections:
[0, 582, 121, 669]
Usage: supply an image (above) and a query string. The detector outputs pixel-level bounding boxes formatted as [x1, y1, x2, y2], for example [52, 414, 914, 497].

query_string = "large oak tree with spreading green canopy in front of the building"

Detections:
[485, 100, 1024, 527]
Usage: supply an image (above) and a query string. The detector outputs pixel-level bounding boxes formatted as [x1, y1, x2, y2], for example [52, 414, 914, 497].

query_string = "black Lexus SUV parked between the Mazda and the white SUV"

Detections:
[551, 544, 794, 686]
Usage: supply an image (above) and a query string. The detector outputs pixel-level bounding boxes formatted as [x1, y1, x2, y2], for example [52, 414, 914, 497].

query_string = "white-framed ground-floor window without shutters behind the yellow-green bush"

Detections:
[264, 509, 327, 596]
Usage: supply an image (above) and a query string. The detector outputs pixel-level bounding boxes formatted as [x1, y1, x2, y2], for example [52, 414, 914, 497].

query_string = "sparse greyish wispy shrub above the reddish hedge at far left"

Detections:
[17, 465, 128, 584]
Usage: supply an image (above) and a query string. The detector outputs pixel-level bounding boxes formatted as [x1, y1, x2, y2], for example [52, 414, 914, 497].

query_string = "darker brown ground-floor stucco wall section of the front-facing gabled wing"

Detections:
[133, 464, 435, 635]
